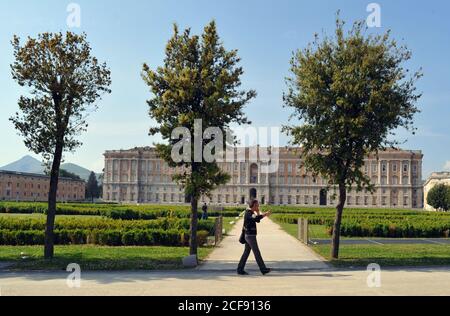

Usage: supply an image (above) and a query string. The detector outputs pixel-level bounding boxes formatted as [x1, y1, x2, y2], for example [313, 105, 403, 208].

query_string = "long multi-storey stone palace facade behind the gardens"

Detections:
[103, 147, 423, 209]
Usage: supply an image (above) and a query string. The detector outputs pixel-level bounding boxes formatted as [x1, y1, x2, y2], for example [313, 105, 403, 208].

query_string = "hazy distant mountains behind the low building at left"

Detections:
[0, 156, 100, 181]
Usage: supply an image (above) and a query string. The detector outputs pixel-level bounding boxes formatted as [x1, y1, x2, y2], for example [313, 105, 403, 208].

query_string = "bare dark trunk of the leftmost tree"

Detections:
[44, 141, 63, 259]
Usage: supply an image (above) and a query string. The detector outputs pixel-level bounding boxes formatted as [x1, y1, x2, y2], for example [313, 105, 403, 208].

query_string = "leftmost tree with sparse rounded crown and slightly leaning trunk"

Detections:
[11, 32, 111, 259]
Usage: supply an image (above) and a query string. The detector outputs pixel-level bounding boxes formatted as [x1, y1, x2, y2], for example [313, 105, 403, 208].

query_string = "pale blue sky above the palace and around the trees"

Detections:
[0, 0, 450, 176]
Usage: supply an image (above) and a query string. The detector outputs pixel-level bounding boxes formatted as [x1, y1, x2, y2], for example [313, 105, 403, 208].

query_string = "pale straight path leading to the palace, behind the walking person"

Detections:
[198, 218, 328, 272]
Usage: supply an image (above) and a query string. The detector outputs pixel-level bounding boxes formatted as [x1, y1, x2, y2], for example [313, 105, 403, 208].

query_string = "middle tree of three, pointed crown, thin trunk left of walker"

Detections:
[142, 21, 256, 255]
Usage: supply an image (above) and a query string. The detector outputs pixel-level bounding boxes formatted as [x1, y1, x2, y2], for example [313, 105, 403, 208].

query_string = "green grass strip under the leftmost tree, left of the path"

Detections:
[0, 245, 213, 270]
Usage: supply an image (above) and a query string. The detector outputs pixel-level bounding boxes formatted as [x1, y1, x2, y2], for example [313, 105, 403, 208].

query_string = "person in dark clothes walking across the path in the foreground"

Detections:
[237, 200, 271, 275]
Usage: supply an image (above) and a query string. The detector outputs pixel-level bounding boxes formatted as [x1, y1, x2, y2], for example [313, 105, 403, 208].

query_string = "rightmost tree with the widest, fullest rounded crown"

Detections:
[284, 15, 422, 259]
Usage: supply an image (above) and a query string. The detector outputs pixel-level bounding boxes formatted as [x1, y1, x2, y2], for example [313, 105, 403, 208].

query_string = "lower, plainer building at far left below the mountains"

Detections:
[0, 171, 86, 202]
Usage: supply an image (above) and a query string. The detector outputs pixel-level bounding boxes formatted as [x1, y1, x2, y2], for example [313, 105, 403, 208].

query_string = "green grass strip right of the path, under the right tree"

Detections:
[312, 245, 450, 267]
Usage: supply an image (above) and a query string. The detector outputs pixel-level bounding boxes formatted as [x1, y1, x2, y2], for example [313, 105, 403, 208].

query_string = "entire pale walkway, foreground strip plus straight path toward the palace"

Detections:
[0, 220, 450, 297]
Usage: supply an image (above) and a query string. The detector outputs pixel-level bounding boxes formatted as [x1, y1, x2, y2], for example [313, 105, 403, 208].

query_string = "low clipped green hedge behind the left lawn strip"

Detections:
[0, 216, 222, 246]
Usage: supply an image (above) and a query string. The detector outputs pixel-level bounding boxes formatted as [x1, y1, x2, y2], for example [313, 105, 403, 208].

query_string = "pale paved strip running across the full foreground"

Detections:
[0, 268, 450, 297]
